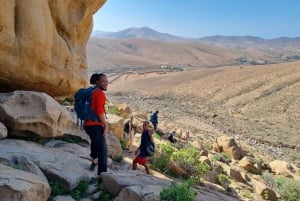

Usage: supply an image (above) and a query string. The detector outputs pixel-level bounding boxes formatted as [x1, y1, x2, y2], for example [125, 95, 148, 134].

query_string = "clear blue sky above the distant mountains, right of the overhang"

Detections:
[93, 0, 300, 39]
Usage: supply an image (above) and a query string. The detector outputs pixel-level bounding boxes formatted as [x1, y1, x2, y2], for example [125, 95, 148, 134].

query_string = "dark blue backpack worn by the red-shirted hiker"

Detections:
[74, 87, 99, 125]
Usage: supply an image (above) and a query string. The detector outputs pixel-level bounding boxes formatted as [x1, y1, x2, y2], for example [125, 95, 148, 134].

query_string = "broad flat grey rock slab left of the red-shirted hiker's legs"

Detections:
[0, 139, 95, 192]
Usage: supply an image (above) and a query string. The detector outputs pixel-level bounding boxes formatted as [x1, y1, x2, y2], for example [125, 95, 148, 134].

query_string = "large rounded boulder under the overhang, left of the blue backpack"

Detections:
[0, 91, 86, 139]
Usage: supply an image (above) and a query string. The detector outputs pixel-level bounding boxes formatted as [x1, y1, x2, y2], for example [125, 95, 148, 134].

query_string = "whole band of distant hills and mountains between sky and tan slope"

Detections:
[87, 27, 300, 71]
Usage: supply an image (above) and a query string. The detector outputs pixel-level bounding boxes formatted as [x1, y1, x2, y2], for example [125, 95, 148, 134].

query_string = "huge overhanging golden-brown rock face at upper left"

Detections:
[0, 0, 106, 97]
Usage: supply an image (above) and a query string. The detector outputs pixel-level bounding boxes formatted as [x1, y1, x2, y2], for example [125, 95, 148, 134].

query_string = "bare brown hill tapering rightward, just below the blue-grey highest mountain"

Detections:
[87, 38, 241, 72]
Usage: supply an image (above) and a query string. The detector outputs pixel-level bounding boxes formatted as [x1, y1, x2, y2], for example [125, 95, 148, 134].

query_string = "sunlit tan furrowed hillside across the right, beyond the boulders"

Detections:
[107, 62, 300, 165]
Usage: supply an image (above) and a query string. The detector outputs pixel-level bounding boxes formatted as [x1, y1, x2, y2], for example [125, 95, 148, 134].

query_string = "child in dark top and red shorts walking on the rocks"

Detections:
[132, 121, 154, 174]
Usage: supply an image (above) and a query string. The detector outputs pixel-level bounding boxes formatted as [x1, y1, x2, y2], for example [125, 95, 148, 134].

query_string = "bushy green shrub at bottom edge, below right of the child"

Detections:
[159, 180, 197, 201]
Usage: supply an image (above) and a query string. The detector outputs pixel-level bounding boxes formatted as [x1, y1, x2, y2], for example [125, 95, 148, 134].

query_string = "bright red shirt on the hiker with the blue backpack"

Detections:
[84, 89, 106, 126]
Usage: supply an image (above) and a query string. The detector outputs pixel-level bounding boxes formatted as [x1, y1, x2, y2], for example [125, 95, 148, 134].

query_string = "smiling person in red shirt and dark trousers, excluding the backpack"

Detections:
[84, 73, 108, 182]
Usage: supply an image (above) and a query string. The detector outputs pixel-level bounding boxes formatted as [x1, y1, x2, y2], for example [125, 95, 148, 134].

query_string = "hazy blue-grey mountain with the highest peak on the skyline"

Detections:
[92, 27, 185, 41]
